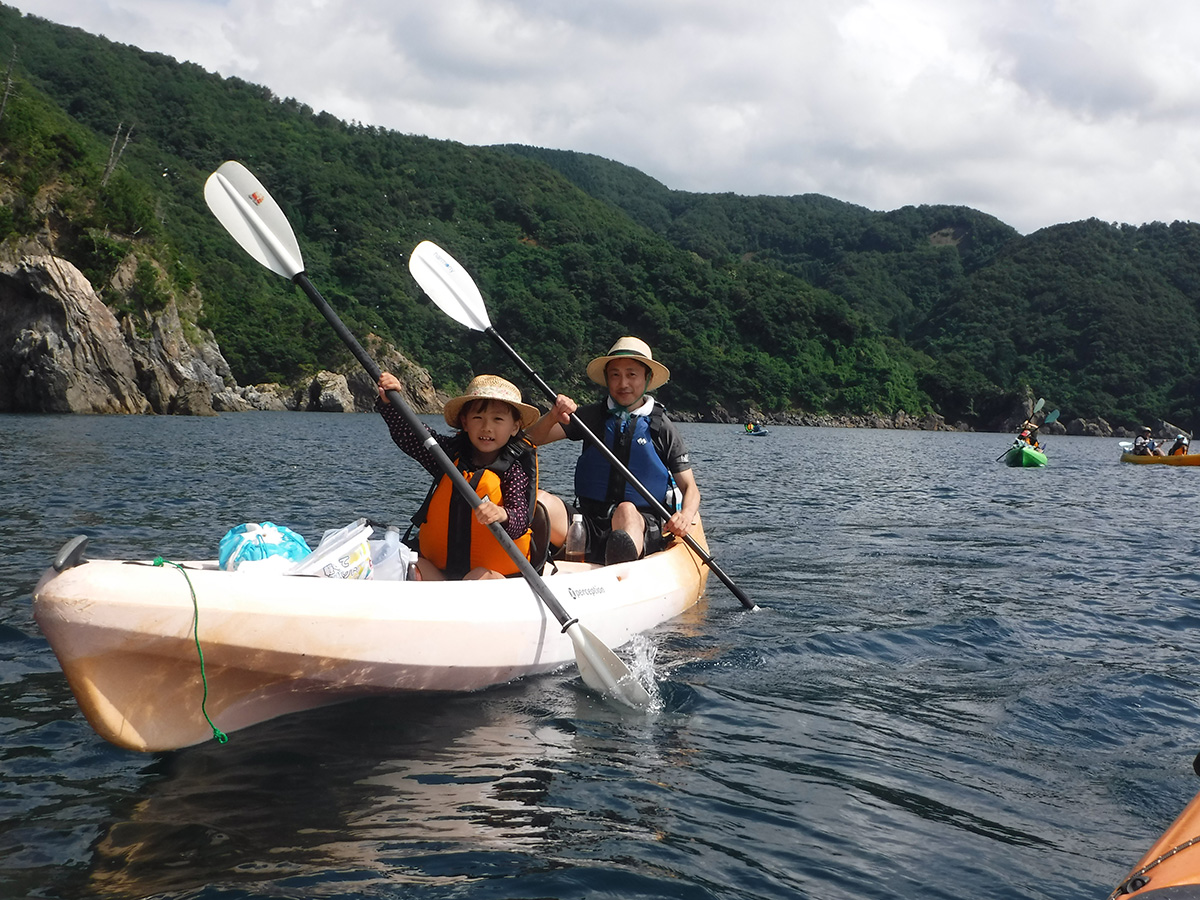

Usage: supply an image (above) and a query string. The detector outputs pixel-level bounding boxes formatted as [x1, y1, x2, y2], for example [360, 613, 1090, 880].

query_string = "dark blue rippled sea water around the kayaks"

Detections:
[0, 413, 1200, 900]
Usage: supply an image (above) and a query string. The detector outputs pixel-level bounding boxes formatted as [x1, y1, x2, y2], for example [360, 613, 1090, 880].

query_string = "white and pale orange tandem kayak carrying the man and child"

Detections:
[34, 520, 708, 751]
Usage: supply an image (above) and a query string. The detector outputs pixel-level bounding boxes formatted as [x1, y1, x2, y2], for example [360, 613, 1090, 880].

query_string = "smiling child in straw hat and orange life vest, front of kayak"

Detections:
[376, 372, 541, 581]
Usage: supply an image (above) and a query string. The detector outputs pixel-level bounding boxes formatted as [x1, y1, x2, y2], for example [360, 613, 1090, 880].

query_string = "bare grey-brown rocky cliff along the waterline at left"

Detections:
[0, 251, 444, 415]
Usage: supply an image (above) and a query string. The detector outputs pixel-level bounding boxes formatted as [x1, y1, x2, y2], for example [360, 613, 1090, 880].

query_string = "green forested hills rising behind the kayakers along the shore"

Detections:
[0, 6, 1200, 427]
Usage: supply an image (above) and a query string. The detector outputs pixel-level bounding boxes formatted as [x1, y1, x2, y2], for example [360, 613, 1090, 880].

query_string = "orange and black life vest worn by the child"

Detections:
[418, 438, 538, 578]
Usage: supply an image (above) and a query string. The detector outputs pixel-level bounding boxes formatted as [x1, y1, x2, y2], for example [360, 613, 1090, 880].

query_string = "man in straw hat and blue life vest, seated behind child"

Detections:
[529, 337, 700, 565]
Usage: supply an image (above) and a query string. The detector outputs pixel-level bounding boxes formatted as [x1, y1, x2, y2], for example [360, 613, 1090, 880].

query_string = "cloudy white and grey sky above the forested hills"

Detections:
[5, 0, 1200, 233]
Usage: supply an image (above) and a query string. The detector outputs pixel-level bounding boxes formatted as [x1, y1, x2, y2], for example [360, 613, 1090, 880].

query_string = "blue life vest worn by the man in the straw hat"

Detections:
[575, 403, 679, 515]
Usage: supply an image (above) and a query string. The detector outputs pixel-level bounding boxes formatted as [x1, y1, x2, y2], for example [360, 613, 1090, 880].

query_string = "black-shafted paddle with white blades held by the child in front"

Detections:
[204, 160, 650, 708]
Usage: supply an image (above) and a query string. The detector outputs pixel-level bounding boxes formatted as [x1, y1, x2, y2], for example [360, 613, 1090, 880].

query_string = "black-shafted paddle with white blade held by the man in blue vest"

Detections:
[408, 241, 758, 610]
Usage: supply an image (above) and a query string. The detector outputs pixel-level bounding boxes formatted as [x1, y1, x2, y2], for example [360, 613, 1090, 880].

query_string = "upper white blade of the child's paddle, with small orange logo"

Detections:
[204, 160, 304, 281]
